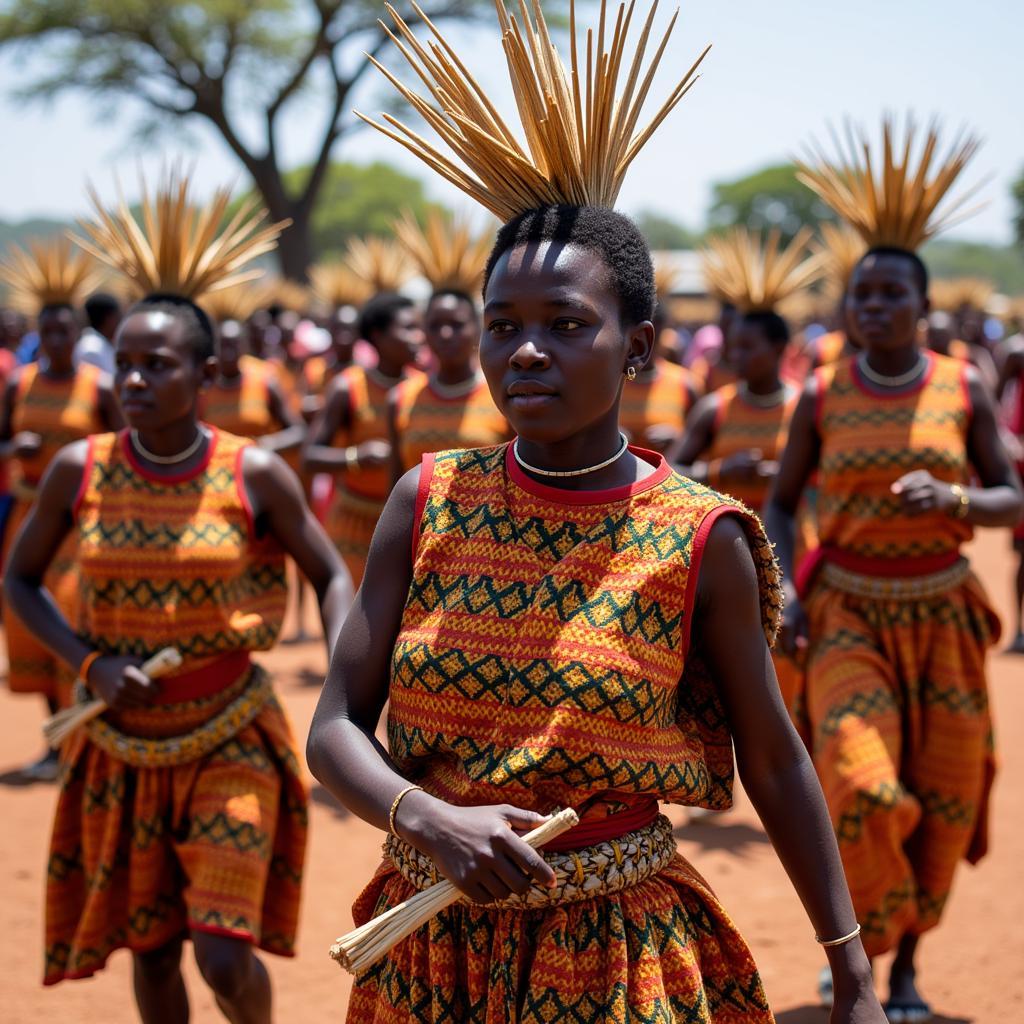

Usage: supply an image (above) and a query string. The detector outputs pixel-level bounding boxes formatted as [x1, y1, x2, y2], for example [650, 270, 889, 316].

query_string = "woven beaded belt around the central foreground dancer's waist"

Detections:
[384, 814, 676, 910]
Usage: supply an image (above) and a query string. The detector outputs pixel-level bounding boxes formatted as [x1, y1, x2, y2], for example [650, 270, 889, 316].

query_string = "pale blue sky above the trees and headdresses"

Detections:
[0, 0, 1024, 243]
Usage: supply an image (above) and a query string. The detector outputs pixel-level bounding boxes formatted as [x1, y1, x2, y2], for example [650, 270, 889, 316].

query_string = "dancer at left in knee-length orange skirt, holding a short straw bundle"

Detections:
[6, 177, 351, 1024]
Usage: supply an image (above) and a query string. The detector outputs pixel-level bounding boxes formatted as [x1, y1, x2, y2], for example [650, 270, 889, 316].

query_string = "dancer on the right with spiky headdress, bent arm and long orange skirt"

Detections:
[767, 119, 1021, 1021]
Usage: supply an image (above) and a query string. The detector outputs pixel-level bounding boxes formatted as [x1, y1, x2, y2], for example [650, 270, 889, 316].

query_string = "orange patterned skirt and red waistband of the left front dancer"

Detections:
[44, 668, 307, 985]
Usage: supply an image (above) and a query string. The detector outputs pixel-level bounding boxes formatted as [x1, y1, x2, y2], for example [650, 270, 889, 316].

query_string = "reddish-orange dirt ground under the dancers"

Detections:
[0, 531, 1024, 1024]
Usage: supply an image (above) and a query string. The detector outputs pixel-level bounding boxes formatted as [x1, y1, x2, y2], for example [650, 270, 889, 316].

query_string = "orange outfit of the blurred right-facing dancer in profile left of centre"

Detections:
[327, 366, 420, 587]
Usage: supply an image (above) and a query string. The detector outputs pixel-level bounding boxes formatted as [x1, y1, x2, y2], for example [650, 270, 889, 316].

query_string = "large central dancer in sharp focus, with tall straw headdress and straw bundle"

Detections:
[307, 5, 883, 1024]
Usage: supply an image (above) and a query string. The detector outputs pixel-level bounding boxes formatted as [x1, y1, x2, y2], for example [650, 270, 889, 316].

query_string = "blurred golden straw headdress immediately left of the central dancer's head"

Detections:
[394, 212, 492, 295]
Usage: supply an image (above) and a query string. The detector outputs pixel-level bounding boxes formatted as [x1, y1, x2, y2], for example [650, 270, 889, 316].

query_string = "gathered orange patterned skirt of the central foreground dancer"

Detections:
[348, 843, 773, 1024]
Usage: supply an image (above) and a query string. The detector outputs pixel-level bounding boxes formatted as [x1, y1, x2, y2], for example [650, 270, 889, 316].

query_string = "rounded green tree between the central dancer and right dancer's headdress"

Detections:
[708, 164, 836, 242]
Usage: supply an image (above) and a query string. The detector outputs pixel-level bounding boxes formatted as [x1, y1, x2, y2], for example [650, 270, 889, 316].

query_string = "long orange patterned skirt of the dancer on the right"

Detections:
[806, 574, 999, 955]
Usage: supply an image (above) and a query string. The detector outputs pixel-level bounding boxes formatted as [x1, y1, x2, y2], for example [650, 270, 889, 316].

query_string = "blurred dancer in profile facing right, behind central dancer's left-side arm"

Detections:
[302, 293, 423, 587]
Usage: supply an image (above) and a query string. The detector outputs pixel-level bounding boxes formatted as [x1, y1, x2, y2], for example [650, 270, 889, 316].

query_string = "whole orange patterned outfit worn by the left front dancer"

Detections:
[44, 431, 306, 984]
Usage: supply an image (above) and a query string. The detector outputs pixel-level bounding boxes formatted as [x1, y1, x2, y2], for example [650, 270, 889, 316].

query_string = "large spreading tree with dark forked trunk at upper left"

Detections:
[0, 0, 481, 281]
